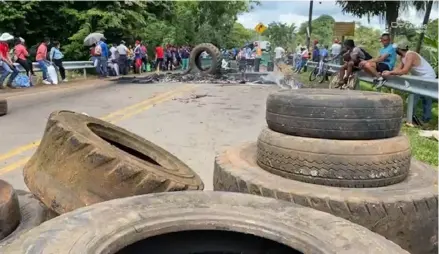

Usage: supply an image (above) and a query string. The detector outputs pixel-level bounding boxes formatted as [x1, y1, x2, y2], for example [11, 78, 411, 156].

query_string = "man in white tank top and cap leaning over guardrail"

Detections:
[382, 41, 437, 122]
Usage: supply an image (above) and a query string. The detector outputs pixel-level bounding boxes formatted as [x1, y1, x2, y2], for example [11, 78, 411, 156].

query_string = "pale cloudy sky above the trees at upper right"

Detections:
[238, 0, 439, 30]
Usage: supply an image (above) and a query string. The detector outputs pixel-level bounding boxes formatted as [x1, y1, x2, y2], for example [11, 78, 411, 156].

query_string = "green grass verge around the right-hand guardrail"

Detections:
[296, 68, 439, 166]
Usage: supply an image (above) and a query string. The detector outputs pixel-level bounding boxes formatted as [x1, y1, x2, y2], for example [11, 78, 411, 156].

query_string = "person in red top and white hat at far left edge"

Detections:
[0, 33, 18, 89]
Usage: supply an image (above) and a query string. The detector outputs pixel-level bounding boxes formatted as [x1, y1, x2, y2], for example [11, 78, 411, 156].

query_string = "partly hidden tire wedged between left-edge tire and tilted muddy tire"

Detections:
[0, 190, 56, 246]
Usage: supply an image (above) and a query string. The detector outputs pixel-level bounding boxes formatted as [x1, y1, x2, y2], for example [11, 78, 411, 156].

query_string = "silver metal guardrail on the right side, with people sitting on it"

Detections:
[307, 61, 438, 123]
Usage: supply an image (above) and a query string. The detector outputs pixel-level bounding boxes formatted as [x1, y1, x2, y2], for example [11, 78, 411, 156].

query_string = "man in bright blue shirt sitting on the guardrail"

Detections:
[359, 33, 396, 86]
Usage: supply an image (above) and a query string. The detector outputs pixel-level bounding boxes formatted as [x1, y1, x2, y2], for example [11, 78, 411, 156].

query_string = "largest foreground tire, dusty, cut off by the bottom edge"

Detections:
[1, 191, 407, 254]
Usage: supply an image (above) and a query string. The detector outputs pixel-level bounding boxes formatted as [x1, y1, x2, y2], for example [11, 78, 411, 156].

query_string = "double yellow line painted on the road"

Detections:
[0, 85, 196, 175]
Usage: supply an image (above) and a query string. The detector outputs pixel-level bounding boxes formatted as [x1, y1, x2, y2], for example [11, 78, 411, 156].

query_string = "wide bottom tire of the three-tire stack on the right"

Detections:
[213, 143, 438, 254]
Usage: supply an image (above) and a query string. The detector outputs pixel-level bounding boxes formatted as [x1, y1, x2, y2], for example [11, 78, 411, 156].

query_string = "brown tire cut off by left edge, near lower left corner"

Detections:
[0, 180, 21, 241]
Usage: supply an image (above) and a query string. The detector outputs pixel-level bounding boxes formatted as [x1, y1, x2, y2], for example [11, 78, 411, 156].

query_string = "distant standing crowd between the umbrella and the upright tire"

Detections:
[90, 38, 192, 77]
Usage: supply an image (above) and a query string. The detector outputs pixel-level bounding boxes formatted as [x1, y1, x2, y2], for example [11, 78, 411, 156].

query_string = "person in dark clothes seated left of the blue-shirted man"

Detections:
[337, 40, 372, 87]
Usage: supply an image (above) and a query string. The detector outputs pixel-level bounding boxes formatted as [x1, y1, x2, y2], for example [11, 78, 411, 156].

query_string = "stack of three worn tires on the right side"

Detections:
[214, 89, 438, 254]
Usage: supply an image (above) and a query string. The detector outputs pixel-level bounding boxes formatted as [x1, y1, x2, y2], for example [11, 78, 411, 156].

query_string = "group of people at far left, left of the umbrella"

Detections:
[0, 33, 68, 89]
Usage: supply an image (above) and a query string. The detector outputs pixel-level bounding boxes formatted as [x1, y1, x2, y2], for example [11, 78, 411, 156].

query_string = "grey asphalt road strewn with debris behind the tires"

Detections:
[0, 81, 277, 190]
